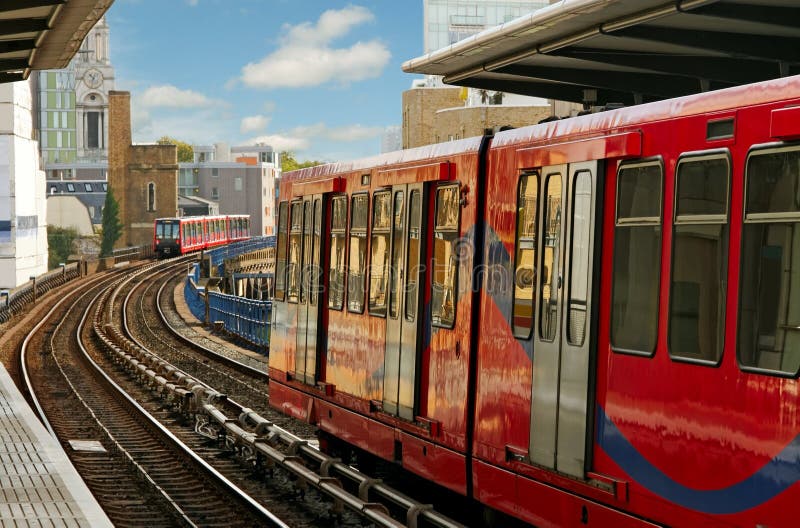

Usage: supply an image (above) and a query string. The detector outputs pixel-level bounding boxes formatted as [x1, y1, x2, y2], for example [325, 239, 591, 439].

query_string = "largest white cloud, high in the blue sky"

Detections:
[241, 6, 391, 88]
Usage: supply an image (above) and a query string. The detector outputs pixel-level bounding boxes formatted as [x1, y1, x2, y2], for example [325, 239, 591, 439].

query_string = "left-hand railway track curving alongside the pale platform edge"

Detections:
[23, 260, 287, 526]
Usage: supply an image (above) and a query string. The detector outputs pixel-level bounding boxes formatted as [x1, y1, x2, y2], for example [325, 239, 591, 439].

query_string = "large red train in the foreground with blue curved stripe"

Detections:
[269, 77, 800, 527]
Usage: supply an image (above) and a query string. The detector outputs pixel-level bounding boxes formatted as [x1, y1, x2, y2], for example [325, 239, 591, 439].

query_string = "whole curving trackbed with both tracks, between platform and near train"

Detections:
[10, 262, 462, 527]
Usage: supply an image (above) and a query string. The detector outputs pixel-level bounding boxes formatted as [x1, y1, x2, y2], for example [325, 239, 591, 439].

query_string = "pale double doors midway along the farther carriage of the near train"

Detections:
[383, 183, 426, 420]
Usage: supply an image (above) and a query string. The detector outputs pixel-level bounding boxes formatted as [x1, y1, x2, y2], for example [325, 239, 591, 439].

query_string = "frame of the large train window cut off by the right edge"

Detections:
[735, 143, 800, 379]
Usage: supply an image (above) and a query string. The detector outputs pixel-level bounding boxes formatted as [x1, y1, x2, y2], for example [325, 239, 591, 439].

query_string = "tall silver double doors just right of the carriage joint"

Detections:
[530, 161, 598, 478]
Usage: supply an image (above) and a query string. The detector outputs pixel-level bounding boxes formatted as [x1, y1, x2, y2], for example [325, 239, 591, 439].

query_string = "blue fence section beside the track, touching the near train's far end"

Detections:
[208, 292, 272, 348]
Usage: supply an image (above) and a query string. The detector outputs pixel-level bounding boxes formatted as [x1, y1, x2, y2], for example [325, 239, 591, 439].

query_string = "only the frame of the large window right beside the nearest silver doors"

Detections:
[608, 156, 666, 358]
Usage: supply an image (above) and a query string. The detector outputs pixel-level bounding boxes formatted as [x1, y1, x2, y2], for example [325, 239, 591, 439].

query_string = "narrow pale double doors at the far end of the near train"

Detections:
[294, 194, 325, 385]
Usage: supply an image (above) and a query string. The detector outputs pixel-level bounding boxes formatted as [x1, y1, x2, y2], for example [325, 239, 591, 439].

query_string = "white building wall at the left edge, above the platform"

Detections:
[0, 81, 47, 288]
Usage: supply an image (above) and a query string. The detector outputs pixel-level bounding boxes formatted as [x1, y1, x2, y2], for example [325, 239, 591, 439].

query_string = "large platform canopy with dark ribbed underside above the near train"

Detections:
[403, 0, 800, 105]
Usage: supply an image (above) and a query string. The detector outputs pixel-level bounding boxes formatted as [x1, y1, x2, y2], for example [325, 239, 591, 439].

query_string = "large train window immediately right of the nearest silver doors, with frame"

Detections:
[611, 162, 663, 355]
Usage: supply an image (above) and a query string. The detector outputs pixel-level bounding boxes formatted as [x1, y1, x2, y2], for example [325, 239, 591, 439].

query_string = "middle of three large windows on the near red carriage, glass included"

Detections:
[668, 155, 730, 363]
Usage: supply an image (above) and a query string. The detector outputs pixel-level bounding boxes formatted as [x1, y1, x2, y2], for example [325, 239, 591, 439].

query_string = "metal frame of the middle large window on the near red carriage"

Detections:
[659, 148, 733, 368]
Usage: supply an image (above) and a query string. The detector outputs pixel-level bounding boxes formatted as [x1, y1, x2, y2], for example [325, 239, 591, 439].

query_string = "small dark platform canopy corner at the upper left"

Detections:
[0, 0, 114, 82]
